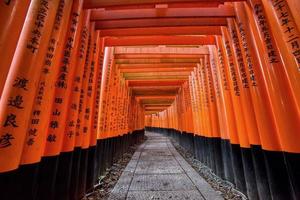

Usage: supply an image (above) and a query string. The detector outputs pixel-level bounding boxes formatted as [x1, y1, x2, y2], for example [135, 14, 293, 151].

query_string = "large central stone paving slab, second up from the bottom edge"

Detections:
[129, 174, 196, 191]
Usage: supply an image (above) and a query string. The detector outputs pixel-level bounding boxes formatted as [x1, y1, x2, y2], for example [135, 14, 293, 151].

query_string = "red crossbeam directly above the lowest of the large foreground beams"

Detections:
[98, 26, 221, 37]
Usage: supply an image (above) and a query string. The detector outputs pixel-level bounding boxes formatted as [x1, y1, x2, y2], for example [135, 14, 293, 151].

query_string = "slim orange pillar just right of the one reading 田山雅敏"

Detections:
[62, 10, 90, 152]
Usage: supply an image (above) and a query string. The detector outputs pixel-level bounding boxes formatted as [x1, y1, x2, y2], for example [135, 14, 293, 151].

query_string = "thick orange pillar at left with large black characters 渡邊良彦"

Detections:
[0, 0, 59, 172]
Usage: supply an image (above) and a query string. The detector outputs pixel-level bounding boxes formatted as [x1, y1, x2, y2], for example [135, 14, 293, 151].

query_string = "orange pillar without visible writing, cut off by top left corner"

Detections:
[0, 0, 30, 97]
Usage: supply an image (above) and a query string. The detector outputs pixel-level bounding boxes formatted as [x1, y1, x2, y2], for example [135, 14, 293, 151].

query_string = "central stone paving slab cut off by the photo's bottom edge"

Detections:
[127, 190, 204, 200]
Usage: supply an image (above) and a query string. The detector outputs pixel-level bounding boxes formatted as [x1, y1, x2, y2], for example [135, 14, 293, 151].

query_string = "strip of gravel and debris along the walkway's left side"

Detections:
[82, 136, 146, 200]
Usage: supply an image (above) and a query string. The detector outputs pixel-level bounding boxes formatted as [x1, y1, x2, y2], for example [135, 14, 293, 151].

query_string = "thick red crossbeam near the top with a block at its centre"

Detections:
[91, 5, 235, 21]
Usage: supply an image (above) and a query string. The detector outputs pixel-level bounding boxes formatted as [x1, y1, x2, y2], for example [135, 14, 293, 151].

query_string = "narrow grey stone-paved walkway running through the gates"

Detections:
[109, 132, 223, 200]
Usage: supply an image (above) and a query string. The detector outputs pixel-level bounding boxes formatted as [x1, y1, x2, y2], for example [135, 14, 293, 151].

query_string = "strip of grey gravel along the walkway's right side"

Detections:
[171, 139, 248, 200]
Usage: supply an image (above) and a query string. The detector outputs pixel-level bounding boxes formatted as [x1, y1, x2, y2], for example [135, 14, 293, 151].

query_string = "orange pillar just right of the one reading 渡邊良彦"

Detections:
[21, 0, 73, 164]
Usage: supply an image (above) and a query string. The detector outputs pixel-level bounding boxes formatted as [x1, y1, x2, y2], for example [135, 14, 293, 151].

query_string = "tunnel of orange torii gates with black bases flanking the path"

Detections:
[0, 0, 300, 200]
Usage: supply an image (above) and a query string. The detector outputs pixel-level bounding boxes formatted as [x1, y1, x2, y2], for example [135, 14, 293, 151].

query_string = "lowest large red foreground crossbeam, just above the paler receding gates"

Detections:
[104, 36, 215, 46]
